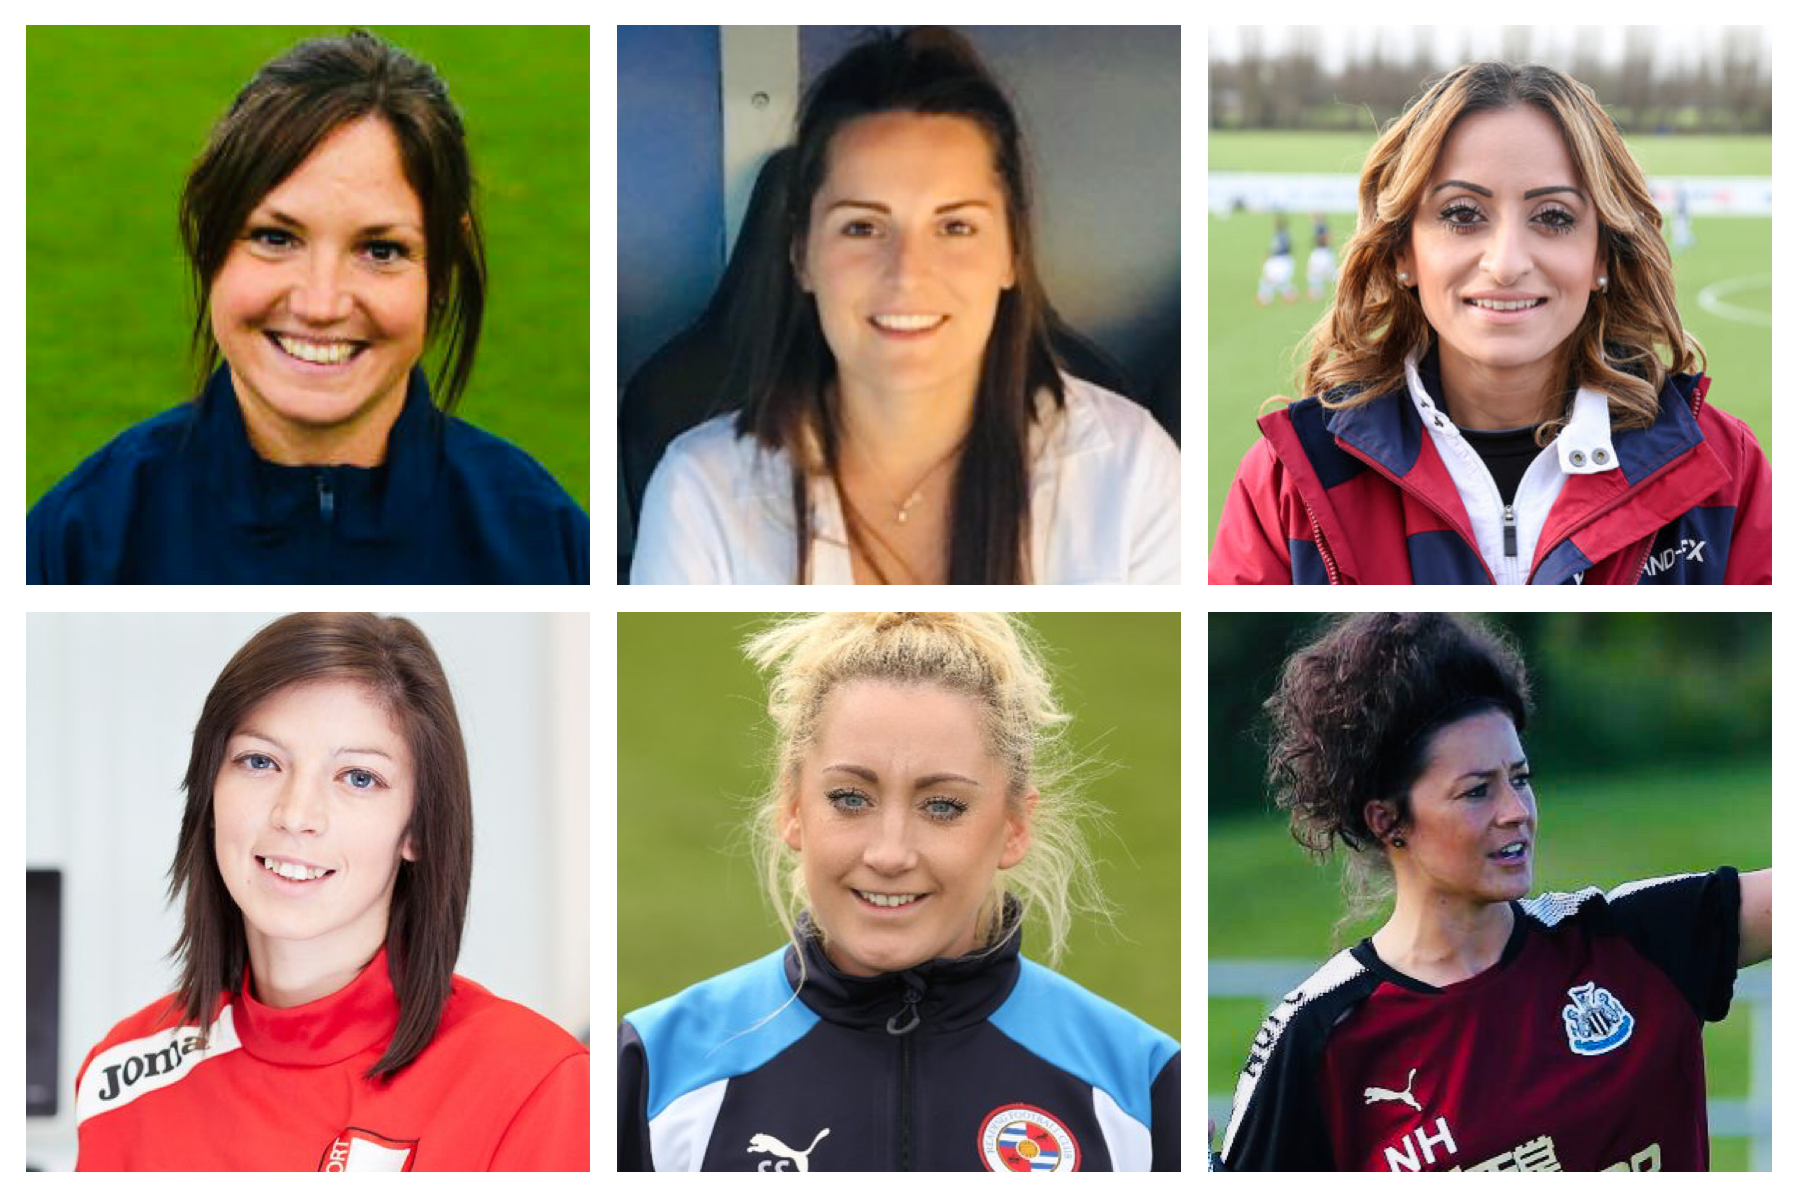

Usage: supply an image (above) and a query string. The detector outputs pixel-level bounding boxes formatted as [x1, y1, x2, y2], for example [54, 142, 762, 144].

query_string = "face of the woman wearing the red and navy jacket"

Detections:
[1395, 104, 1604, 394]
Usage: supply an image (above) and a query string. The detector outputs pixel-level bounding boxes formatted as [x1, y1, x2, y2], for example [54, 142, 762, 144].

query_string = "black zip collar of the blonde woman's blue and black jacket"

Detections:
[783, 898, 1021, 1035]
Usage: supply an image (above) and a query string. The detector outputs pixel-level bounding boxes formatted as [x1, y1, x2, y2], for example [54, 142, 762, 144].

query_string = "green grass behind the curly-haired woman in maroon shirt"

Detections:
[1206, 758, 1773, 1170]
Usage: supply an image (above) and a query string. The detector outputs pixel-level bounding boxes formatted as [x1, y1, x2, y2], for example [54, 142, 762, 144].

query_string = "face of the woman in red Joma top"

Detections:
[212, 679, 414, 960]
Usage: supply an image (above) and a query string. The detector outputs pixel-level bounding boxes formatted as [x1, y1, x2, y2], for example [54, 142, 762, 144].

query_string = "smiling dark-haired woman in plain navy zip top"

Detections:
[27, 31, 589, 583]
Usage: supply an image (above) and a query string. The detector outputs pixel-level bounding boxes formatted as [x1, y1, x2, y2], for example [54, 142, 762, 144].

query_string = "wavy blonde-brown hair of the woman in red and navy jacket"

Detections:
[1300, 63, 1706, 445]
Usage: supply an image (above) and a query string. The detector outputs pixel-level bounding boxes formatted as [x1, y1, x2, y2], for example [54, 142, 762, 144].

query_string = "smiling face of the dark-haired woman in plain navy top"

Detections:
[211, 117, 427, 461]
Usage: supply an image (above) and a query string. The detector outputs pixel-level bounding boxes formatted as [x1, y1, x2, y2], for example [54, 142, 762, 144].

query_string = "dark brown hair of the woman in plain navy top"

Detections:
[182, 29, 488, 410]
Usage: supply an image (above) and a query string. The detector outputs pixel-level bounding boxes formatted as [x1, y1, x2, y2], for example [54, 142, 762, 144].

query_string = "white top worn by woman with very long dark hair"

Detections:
[632, 374, 1181, 583]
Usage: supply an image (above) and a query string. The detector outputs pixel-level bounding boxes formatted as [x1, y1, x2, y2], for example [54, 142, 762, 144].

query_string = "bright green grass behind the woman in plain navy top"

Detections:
[25, 27, 589, 508]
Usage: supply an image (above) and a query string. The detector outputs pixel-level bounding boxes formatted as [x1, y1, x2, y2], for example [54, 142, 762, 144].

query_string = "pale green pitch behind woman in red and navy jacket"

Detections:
[1206, 130, 1775, 544]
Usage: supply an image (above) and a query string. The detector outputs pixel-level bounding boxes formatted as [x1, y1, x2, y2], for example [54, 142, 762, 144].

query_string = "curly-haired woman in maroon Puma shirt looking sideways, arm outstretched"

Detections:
[1213, 612, 1775, 1172]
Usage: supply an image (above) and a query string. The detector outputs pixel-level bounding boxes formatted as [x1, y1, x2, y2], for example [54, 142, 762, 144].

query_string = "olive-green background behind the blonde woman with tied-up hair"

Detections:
[617, 614, 1181, 1037]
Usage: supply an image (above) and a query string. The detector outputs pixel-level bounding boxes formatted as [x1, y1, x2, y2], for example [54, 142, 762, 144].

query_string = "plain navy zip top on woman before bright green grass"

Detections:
[25, 365, 589, 583]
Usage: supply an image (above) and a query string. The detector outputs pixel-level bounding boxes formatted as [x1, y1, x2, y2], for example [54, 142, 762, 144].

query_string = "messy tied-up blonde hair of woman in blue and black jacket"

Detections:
[743, 612, 1109, 965]
